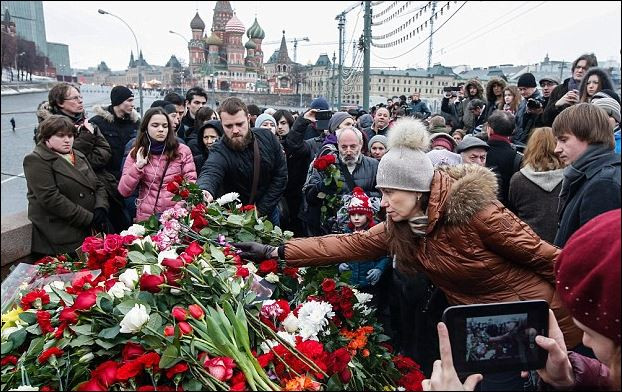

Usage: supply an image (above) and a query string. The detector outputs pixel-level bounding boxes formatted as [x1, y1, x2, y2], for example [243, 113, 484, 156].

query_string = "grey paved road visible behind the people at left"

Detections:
[0, 86, 159, 217]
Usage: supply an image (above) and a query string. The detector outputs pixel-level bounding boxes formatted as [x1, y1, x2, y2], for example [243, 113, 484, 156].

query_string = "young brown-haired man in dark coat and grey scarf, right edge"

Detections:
[553, 103, 620, 248]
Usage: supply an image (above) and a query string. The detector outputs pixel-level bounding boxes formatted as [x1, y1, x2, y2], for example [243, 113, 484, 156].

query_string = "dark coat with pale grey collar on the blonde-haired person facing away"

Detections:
[506, 166, 564, 243]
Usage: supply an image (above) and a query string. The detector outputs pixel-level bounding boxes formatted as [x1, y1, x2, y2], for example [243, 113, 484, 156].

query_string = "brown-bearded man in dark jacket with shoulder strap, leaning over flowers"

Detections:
[197, 97, 287, 225]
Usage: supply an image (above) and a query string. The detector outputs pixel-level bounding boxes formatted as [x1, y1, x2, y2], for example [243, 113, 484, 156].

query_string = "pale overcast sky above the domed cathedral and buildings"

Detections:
[43, 1, 621, 70]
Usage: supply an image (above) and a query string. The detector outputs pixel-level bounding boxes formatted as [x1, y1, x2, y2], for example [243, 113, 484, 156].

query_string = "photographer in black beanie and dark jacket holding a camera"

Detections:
[512, 72, 545, 146]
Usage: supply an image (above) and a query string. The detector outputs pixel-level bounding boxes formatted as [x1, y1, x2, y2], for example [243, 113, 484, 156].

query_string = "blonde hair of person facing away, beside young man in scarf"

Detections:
[523, 127, 564, 172]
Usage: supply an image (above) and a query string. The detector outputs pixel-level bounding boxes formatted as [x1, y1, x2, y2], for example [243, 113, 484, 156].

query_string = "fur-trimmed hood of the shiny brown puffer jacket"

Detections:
[428, 164, 499, 231]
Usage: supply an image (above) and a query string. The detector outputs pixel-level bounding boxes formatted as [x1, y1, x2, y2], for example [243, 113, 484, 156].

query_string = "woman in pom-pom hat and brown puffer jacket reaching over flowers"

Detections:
[238, 118, 581, 386]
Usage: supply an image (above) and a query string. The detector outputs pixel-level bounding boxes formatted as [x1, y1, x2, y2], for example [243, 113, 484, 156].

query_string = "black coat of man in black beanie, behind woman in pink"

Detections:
[90, 105, 140, 181]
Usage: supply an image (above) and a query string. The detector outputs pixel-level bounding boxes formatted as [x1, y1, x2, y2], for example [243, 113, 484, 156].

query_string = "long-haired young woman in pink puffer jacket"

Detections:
[119, 107, 197, 222]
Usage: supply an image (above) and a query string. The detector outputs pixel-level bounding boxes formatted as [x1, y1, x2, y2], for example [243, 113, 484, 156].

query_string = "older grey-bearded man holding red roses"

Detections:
[302, 126, 380, 235]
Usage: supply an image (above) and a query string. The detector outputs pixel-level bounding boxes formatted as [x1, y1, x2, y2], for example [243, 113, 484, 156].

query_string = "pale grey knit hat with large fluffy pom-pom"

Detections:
[376, 117, 434, 192]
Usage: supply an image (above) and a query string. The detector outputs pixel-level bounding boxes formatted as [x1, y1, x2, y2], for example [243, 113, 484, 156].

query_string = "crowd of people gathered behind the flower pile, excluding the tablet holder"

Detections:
[24, 51, 620, 389]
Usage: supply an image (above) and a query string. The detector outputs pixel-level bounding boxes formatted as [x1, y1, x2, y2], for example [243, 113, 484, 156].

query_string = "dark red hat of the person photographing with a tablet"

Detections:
[555, 208, 620, 346]
